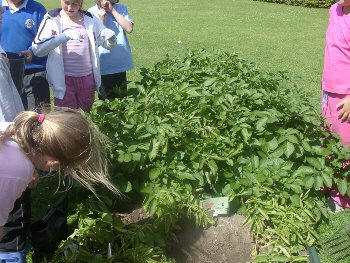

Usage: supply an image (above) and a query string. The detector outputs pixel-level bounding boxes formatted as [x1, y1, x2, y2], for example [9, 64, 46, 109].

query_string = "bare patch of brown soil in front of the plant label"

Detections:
[167, 214, 255, 263]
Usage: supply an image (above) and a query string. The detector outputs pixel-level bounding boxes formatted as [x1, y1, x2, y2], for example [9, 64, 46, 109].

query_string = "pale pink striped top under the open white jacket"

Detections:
[62, 24, 92, 77]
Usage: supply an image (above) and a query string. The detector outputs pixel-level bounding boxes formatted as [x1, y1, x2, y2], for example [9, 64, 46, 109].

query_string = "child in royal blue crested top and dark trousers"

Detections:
[0, 0, 50, 110]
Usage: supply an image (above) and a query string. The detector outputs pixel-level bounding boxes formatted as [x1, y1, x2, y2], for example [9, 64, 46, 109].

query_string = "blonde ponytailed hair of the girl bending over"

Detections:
[0, 108, 119, 194]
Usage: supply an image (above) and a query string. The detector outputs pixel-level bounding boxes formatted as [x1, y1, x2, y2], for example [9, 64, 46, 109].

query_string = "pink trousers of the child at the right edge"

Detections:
[322, 92, 350, 147]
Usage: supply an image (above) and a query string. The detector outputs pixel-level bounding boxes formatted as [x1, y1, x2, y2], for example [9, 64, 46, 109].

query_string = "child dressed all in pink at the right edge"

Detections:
[322, 0, 350, 207]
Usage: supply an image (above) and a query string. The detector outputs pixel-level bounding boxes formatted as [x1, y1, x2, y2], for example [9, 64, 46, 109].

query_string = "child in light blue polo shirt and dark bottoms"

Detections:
[88, 0, 134, 99]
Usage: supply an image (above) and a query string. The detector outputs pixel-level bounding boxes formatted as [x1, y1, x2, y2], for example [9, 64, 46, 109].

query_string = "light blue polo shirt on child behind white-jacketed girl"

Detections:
[88, 3, 133, 75]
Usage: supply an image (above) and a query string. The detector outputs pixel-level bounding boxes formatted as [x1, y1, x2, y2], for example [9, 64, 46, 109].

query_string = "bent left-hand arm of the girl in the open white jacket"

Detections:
[32, 18, 81, 57]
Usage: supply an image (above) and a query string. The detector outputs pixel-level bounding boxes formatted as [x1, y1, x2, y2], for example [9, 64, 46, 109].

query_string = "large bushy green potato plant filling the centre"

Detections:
[56, 50, 350, 262]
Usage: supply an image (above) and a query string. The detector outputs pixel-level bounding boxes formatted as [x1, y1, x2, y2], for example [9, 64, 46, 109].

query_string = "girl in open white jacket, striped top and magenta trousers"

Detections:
[32, 0, 116, 111]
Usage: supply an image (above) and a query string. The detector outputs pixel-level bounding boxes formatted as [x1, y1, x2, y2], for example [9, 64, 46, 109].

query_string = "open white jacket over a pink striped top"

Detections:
[32, 8, 115, 99]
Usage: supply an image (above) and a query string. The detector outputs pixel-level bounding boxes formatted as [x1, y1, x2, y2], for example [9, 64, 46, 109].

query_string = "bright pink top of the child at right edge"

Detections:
[322, 3, 350, 94]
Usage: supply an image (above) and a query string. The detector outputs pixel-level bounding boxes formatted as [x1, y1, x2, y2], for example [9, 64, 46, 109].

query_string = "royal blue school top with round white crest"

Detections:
[0, 0, 47, 74]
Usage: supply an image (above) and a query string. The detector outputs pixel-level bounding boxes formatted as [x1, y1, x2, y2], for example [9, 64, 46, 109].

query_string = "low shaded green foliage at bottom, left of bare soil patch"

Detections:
[54, 205, 173, 263]
